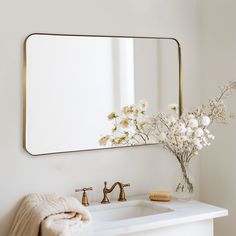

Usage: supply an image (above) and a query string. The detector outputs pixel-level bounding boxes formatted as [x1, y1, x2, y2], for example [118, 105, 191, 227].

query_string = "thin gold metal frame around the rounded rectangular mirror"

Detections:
[23, 33, 183, 156]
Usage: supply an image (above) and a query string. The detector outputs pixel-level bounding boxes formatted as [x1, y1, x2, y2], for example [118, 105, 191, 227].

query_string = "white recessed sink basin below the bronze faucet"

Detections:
[89, 200, 173, 222]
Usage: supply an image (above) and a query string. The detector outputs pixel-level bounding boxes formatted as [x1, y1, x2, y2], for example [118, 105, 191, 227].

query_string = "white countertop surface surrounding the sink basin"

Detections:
[74, 196, 228, 236]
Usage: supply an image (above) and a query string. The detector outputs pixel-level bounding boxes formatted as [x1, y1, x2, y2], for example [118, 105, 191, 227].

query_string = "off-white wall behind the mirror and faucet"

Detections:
[0, 0, 201, 236]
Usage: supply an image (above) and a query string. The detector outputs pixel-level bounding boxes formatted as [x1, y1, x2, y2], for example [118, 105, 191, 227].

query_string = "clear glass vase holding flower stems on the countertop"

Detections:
[175, 162, 194, 201]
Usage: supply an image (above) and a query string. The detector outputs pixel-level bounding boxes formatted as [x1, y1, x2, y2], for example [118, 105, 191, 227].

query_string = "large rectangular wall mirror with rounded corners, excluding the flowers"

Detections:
[24, 34, 182, 155]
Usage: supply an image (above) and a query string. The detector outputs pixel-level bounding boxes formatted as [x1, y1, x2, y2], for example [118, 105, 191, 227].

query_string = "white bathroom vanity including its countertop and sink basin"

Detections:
[78, 197, 228, 236]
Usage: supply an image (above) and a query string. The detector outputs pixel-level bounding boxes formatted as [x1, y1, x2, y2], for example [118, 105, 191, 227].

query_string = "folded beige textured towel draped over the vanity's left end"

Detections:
[8, 193, 91, 236]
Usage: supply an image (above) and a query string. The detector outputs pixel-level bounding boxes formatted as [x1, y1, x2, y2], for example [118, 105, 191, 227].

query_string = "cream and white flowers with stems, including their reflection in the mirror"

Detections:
[99, 81, 236, 197]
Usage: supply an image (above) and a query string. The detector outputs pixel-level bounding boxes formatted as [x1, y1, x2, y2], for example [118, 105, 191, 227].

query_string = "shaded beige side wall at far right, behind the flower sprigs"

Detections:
[198, 0, 236, 236]
